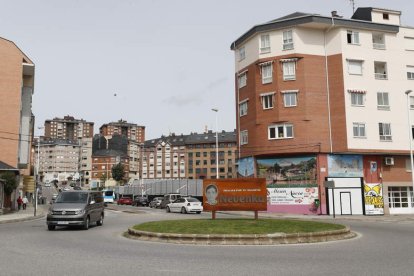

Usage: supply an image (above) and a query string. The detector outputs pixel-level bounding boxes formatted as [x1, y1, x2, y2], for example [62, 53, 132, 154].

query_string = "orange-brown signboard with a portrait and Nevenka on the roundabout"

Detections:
[203, 178, 267, 211]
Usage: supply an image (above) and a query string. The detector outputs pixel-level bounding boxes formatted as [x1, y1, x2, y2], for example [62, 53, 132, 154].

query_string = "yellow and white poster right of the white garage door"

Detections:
[364, 183, 384, 215]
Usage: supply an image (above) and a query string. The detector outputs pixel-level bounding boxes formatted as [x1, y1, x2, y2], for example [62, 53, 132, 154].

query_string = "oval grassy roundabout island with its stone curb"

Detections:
[126, 219, 356, 245]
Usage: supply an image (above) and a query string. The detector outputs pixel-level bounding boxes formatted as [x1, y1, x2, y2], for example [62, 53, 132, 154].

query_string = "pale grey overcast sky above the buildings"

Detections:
[0, 0, 414, 139]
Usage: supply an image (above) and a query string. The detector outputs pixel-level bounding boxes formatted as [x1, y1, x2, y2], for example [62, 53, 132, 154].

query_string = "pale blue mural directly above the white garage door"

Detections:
[328, 154, 364, 177]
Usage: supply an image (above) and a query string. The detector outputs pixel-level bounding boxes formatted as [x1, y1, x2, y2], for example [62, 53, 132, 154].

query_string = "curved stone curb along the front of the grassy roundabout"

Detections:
[128, 227, 357, 245]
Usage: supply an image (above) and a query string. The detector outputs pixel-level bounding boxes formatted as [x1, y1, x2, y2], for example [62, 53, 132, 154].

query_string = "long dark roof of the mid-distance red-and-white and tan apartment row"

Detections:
[144, 130, 237, 147]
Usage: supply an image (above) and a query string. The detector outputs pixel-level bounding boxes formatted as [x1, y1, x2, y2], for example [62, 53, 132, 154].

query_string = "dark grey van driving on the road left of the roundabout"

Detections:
[46, 190, 105, 230]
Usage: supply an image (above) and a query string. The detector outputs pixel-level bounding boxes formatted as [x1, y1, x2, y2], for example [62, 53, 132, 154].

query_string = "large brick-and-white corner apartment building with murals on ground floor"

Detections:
[231, 7, 414, 215]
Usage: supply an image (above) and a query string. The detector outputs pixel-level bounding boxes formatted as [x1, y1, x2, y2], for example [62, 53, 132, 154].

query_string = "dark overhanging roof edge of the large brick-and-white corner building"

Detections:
[230, 8, 399, 50]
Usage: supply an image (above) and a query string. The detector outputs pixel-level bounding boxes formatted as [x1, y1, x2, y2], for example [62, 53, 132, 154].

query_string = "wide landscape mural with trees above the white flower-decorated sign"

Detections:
[257, 156, 316, 185]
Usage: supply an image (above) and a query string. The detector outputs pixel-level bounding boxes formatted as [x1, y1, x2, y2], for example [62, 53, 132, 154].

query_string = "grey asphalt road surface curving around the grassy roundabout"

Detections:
[0, 206, 414, 275]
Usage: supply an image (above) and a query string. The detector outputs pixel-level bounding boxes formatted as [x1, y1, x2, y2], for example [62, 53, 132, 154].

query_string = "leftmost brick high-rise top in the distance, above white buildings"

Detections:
[44, 115, 94, 140]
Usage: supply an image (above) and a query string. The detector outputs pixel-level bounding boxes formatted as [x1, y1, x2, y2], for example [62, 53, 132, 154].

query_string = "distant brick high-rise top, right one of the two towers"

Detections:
[99, 119, 145, 143]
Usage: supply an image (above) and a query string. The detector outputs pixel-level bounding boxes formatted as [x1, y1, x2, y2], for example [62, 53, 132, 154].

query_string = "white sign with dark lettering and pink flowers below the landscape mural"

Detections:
[267, 187, 318, 205]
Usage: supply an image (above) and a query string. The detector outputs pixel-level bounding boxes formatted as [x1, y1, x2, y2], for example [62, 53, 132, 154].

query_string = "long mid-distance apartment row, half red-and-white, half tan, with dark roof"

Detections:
[142, 130, 237, 179]
